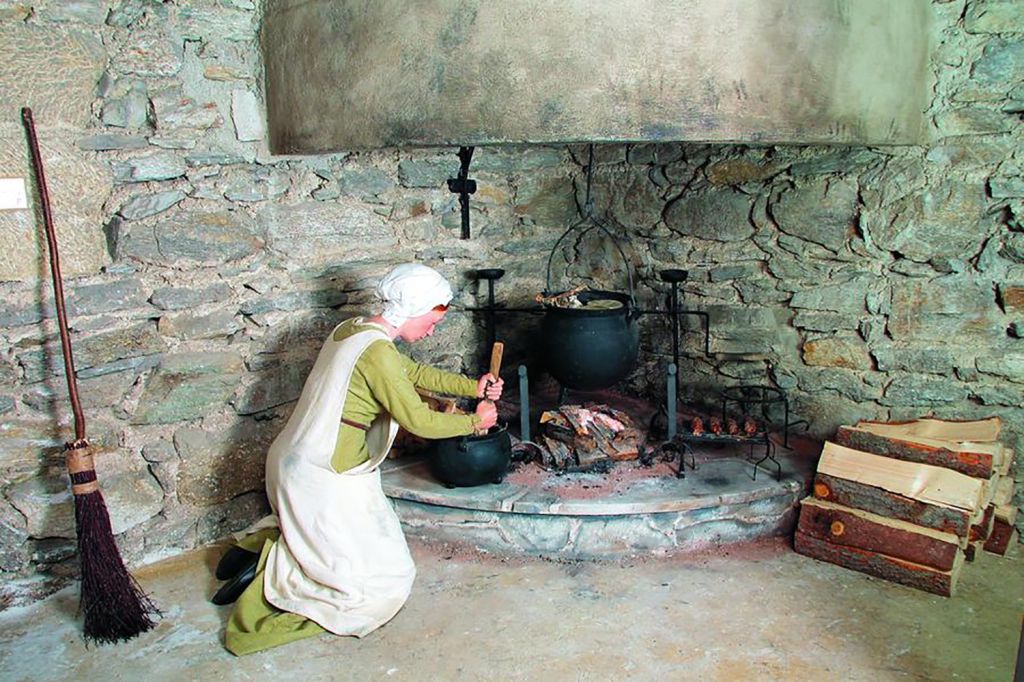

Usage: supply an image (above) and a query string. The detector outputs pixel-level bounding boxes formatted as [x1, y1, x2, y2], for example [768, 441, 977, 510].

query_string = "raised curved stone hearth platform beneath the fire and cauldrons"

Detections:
[382, 452, 813, 559]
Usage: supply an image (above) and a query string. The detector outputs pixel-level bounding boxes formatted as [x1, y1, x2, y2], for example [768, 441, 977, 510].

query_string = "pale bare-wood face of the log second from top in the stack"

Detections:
[818, 442, 987, 514]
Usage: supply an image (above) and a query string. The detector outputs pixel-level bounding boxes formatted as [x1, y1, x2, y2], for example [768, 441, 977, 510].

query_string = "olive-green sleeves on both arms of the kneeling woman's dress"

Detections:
[361, 343, 480, 438]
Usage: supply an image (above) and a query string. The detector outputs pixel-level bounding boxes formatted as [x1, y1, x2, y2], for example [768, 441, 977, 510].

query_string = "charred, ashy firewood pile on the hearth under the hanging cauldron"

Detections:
[538, 403, 640, 470]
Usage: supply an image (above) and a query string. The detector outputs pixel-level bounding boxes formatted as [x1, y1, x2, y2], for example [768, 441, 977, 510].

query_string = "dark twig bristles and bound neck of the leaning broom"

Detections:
[71, 444, 160, 643]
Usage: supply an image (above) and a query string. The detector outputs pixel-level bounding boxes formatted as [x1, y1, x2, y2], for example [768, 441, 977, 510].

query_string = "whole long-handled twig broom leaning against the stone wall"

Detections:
[22, 106, 160, 643]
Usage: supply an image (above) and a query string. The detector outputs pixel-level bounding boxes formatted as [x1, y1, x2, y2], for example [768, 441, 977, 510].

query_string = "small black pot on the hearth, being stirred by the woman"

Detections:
[430, 424, 512, 487]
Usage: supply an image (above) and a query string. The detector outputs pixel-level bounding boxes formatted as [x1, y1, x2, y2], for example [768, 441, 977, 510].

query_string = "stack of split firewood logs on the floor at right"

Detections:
[795, 417, 1017, 596]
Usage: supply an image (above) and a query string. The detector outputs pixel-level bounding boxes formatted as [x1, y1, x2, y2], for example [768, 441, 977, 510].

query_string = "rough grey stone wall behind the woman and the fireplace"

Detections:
[0, 0, 1024, 603]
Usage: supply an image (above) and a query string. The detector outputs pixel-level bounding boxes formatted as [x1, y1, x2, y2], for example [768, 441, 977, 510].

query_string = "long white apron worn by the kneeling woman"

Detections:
[262, 321, 416, 637]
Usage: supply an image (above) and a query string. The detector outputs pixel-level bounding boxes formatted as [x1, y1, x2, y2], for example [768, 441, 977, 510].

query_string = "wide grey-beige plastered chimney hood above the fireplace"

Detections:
[261, 0, 931, 154]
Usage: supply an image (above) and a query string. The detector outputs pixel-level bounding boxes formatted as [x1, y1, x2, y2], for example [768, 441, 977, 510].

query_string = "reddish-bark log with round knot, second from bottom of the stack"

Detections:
[797, 498, 961, 570]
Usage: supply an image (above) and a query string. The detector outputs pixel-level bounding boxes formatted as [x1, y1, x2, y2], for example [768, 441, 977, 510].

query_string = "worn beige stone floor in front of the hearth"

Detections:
[0, 539, 1024, 682]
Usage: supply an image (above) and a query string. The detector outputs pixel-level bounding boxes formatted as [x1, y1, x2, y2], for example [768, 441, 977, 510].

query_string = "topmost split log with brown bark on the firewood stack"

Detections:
[836, 426, 1004, 478]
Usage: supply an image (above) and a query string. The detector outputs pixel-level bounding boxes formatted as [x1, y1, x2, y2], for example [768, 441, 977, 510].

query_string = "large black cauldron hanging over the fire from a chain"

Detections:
[541, 291, 640, 390]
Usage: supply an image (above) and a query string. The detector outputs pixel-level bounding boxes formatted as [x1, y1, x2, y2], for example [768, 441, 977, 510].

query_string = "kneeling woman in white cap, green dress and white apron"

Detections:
[222, 263, 502, 655]
